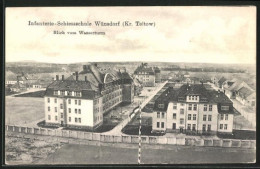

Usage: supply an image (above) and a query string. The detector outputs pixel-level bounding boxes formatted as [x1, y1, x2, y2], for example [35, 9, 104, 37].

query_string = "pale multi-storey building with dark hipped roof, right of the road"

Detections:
[152, 84, 234, 134]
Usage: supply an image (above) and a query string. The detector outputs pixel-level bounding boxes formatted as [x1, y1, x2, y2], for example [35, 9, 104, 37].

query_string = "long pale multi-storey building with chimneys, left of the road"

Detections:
[44, 65, 134, 129]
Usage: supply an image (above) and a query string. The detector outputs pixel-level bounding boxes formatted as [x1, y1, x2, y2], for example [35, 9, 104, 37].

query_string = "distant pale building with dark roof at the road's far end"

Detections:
[134, 63, 161, 87]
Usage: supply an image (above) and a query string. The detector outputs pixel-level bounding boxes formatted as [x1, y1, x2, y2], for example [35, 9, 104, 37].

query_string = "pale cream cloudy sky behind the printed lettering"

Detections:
[5, 6, 256, 64]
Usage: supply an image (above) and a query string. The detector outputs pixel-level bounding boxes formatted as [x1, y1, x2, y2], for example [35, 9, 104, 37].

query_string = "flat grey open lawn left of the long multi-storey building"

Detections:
[5, 97, 44, 125]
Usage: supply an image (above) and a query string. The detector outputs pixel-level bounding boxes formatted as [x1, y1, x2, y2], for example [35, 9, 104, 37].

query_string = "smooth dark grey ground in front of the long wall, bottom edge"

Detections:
[37, 144, 256, 164]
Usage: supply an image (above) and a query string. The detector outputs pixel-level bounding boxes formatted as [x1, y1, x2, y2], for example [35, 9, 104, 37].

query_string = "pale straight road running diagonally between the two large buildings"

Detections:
[102, 81, 168, 135]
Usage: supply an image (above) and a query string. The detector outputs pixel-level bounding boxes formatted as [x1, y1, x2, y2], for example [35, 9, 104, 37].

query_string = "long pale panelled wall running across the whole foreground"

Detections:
[5, 125, 256, 148]
